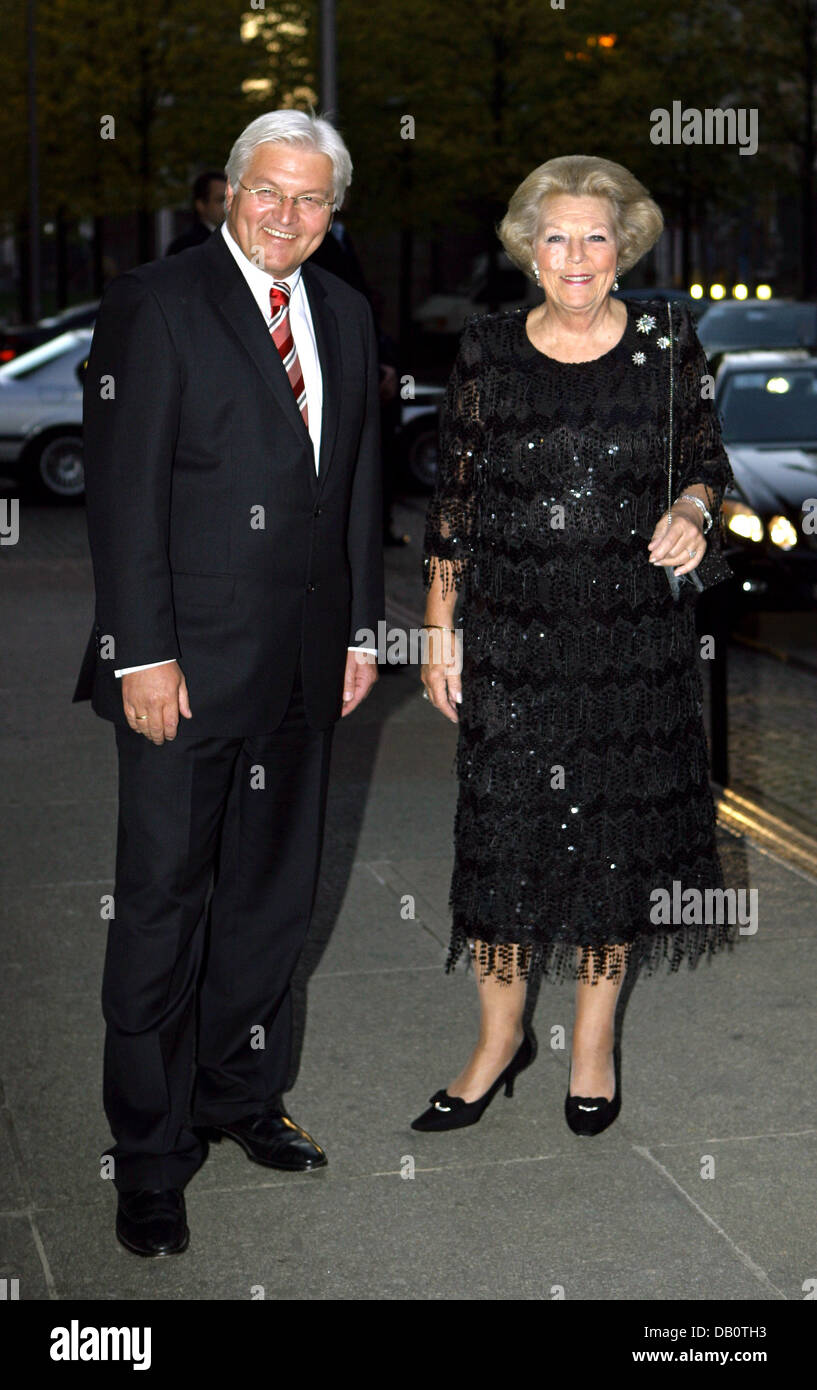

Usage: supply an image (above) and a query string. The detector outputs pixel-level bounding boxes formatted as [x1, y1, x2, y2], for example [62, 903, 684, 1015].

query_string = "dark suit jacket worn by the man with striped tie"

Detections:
[74, 232, 383, 735]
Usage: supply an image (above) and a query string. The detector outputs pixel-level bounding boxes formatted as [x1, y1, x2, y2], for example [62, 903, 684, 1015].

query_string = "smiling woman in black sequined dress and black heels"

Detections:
[414, 156, 734, 1134]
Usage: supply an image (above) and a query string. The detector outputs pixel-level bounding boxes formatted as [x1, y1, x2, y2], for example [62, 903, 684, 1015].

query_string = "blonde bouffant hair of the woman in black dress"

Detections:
[497, 154, 664, 279]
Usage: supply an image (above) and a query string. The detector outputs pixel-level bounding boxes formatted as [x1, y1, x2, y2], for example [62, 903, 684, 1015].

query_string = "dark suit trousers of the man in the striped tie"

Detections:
[103, 677, 332, 1191]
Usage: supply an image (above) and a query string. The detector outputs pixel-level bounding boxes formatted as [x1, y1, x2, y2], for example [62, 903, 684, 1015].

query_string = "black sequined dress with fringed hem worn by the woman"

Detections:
[424, 300, 735, 979]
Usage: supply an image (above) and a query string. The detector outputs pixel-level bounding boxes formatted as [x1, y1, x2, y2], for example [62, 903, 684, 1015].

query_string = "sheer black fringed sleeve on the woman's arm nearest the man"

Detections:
[422, 324, 484, 596]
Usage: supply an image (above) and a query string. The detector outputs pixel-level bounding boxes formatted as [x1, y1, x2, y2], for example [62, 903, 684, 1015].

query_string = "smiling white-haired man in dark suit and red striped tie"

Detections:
[75, 111, 383, 1255]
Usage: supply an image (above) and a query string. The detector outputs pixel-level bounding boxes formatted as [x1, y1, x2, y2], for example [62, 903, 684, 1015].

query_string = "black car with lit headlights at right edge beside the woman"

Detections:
[714, 350, 817, 609]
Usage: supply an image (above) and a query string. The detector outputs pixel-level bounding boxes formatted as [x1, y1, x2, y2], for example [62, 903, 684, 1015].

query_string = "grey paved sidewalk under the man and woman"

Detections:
[0, 503, 817, 1301]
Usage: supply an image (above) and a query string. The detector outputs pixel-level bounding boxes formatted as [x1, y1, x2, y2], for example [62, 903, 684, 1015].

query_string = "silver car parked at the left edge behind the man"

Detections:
[0, 328, 93, 499]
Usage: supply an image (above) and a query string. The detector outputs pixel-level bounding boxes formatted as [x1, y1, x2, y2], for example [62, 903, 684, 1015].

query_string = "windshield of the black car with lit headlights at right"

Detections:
[718, 364, 817, 443]
